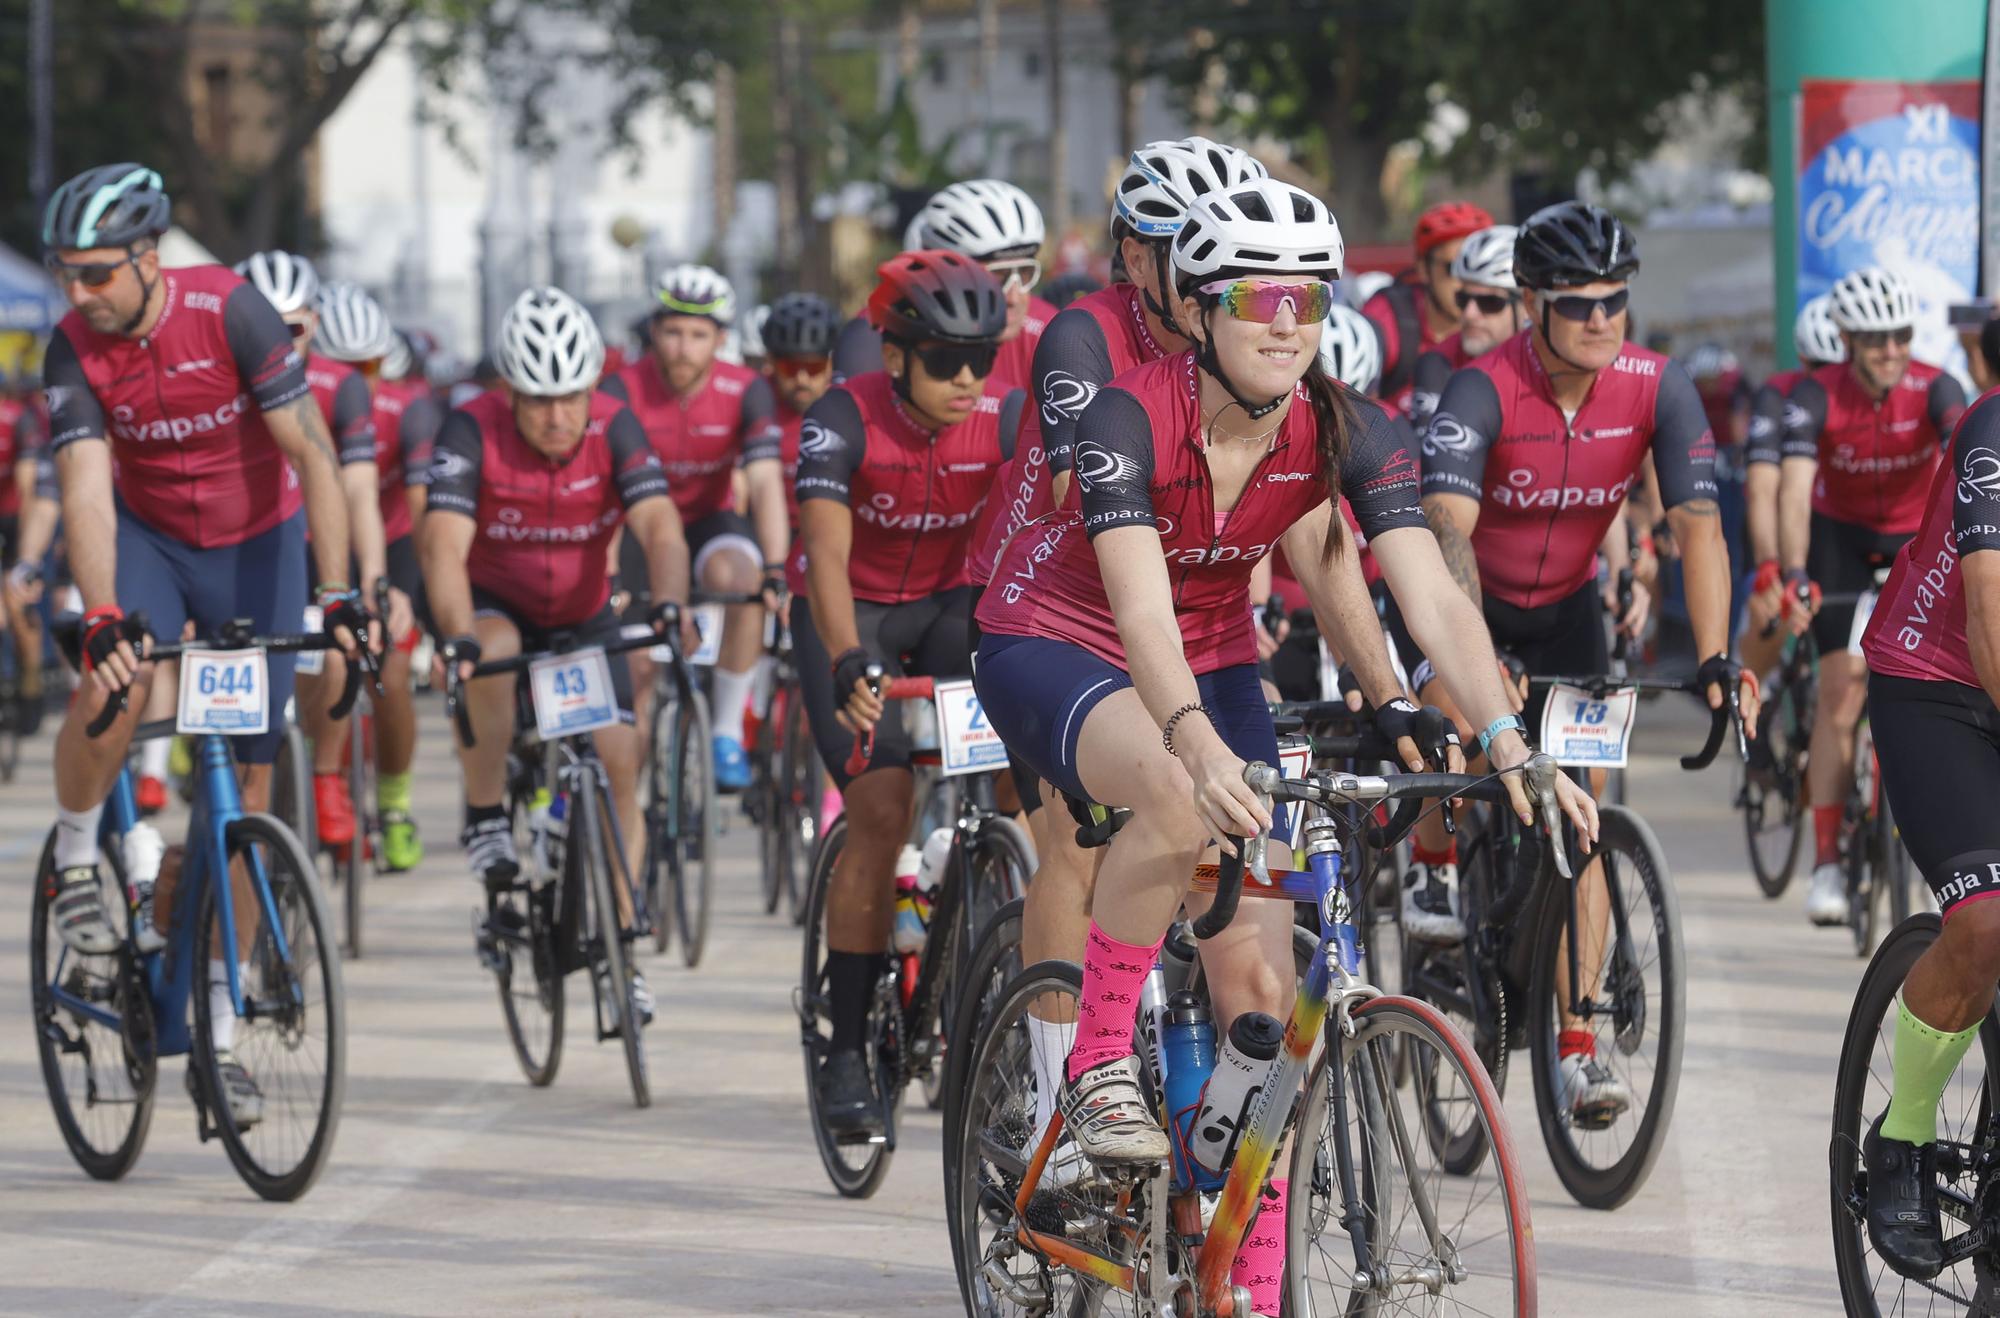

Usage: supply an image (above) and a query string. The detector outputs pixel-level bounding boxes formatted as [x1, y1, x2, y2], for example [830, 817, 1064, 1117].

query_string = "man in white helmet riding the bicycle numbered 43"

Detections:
[420, 288, 688, 1018]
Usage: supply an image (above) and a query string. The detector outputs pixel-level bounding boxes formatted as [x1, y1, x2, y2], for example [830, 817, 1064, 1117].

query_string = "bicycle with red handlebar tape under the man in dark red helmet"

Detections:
[792, 670, 1034, 1198]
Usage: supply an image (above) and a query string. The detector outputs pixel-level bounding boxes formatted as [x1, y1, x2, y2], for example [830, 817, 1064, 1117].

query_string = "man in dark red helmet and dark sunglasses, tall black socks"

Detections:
[792, 252, 1024, 1132]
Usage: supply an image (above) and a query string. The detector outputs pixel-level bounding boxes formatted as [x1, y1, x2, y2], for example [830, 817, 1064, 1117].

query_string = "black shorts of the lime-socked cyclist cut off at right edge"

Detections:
[1868, 672, 2000, 920]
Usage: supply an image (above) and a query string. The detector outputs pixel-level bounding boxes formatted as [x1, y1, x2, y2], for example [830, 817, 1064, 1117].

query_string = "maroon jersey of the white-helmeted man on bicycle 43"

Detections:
[426, 394, 668, 628]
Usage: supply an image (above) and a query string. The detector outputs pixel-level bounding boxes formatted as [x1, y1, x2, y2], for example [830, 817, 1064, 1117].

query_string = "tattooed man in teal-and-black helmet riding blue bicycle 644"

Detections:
[42, 164, 362, 1124]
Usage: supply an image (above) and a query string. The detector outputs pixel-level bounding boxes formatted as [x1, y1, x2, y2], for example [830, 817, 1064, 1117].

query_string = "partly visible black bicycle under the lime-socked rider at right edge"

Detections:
[1826, 912, 2000, 1316]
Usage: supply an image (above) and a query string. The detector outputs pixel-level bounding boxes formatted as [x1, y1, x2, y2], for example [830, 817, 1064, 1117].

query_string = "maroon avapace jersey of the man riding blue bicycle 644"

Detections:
[42, 266, 308, 548]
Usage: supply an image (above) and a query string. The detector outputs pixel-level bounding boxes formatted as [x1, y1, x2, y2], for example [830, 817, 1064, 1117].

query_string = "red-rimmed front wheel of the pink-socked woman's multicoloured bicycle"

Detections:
[1284, 996, 1538, 1316]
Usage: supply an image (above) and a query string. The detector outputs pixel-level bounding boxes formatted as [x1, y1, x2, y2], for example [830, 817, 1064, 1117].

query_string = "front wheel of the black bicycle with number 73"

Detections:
[1528, 806, 1688, 1210]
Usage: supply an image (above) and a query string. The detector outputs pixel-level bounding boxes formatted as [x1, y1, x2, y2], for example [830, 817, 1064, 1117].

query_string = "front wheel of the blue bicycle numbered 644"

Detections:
[192, 814, 346, 1200]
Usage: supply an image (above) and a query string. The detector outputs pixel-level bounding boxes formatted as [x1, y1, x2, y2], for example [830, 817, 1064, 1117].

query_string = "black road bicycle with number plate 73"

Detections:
[1404, 676, 1744, 1210]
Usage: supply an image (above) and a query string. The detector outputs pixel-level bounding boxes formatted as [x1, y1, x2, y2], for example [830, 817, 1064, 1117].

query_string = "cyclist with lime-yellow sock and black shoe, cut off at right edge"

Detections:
[1834, 390, 2000, 1280]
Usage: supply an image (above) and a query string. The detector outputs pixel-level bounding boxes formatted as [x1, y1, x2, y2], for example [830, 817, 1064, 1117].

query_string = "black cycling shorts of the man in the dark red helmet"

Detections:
[792, 586, 972, 790]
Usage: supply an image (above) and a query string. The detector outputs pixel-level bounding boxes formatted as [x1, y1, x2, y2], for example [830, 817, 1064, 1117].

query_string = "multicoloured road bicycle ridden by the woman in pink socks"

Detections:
[950, 756, 1566, 1318]
